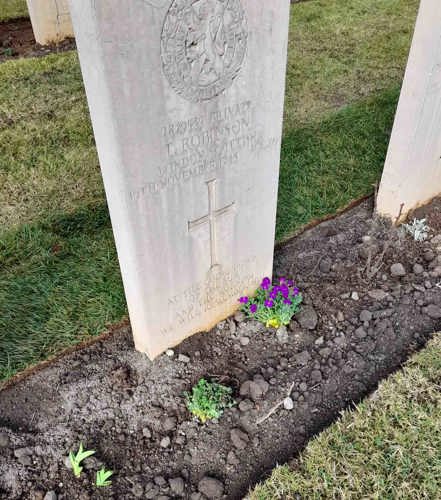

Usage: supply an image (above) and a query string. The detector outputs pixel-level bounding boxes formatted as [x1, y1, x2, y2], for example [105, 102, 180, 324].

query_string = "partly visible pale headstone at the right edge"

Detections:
[377, 0, 441, 220]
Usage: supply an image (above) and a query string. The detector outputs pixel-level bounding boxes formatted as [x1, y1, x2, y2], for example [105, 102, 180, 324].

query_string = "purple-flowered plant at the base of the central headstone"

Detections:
[239, 278, 303, 328]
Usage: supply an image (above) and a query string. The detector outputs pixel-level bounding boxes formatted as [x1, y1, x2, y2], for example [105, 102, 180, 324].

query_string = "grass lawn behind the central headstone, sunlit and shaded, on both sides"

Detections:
[0, 0, 418, 379]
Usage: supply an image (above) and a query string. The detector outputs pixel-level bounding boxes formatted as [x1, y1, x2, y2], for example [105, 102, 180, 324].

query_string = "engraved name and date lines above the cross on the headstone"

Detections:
[129, 101, 280, 202]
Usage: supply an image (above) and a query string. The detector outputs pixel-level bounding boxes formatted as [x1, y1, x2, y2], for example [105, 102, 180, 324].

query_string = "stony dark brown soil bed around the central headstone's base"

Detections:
[0, 196, 441, 500]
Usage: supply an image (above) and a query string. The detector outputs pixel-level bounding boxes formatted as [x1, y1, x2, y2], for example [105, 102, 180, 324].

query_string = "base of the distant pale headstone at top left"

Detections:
[26, 0, 73, 45]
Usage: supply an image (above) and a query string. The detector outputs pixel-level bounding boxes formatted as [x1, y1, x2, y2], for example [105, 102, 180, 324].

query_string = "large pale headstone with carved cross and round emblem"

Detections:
[70, 0, 290, 358]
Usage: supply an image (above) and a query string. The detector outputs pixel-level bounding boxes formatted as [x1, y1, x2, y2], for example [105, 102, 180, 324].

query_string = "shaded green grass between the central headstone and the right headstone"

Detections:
[276, 87, 399, 240]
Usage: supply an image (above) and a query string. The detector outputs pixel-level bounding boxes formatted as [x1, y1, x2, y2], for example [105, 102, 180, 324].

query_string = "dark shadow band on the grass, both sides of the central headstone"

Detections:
[0, 88, 399, 379]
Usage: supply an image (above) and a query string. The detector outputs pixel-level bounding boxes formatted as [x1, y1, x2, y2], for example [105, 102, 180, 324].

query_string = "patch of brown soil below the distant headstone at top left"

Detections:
[0, 18, 75, 62]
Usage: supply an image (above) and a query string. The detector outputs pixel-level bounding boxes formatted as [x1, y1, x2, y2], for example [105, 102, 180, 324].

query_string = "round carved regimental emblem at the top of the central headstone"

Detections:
[161, 0, 247, 102]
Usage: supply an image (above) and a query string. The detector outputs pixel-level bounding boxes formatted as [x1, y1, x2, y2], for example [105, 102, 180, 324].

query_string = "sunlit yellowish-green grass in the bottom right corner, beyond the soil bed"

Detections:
[249, 334, 441, 500]
